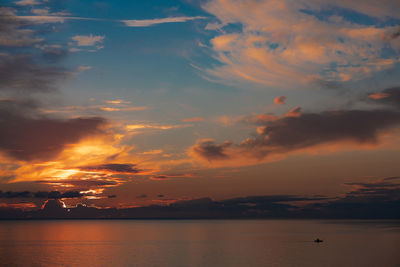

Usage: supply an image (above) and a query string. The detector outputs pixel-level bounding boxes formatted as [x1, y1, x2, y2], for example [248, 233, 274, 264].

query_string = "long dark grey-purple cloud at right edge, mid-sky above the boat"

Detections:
[252, 110, 400, 150]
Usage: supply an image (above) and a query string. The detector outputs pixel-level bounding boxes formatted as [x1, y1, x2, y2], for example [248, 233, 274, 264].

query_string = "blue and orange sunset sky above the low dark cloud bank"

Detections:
[0, 0, 400, 209]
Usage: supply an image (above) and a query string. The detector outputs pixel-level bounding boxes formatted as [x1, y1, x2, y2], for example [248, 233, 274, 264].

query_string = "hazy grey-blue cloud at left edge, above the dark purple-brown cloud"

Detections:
[0, 54, 69, 92]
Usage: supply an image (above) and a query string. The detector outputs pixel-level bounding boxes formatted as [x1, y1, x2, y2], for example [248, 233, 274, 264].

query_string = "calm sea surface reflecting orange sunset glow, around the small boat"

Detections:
[0, 220, 400, 267]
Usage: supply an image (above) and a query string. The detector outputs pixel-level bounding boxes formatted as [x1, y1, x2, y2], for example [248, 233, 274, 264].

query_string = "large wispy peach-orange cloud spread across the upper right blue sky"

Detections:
[203, 0, 400, 88]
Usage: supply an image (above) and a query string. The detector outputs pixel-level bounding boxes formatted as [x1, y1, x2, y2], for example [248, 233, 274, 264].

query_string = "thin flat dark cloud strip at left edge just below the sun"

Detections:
[0, 190, 84, 199]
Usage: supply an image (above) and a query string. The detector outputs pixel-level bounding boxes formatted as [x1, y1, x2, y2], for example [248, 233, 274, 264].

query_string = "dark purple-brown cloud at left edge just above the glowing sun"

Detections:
[0, 100, 105, 161]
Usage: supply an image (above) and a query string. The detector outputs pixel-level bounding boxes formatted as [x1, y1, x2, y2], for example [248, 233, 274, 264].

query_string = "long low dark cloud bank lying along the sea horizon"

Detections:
[0, 177, 400, 219]
